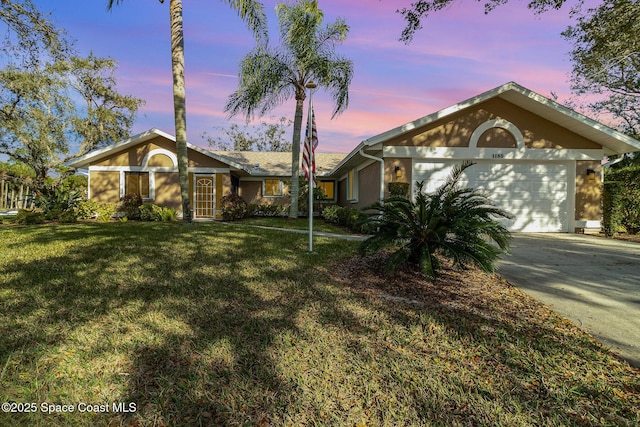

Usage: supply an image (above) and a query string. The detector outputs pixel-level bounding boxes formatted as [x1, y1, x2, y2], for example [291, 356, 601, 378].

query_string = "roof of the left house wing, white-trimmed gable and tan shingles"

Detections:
[67, 128, 346, 176]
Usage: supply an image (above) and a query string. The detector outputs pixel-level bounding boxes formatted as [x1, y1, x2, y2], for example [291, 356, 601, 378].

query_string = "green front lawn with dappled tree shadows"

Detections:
[0, 221, 640, 426]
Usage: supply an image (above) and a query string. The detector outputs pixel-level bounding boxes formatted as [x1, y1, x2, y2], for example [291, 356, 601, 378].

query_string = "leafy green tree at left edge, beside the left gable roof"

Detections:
[0, 52, 142, 188]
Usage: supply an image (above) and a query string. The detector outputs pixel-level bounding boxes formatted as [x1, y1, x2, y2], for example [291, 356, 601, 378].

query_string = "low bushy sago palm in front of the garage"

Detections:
[360, 162, 513, 278]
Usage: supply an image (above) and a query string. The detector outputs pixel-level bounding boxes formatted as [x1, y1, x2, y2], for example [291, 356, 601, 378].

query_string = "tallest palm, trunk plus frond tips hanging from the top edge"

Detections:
[107, 0, 267, 223]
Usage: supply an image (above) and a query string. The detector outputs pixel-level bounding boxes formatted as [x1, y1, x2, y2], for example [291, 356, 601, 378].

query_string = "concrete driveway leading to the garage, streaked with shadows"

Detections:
[498, 233, 640, 367]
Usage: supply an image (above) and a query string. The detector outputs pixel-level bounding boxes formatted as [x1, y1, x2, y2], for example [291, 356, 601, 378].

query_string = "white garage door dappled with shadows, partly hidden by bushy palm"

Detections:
[412, 160, 569, 232]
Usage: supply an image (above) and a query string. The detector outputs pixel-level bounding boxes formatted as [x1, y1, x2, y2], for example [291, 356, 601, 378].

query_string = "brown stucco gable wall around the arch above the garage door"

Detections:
[384, 98, 601, 149]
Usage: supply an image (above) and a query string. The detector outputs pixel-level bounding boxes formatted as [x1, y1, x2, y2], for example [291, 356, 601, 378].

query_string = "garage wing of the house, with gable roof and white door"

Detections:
[331, 82, 640, 232]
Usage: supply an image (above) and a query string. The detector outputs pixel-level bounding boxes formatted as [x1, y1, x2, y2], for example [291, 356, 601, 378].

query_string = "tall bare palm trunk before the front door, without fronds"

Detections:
[169, 0, 191, 223]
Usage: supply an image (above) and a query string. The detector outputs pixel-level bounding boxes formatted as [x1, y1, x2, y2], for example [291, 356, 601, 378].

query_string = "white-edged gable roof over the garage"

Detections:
[332, 82, 640, 173]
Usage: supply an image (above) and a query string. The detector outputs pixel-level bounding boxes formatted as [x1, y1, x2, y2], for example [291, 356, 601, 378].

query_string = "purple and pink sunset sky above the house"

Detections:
[35, 0, 584, 152]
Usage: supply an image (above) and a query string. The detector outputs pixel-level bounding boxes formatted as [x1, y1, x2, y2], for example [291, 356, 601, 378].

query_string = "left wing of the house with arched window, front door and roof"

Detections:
[68, 129, 345, 220]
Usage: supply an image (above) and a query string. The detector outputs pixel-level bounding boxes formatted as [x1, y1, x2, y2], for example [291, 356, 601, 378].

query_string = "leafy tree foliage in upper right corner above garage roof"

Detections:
[563, 0, 640, 138]
